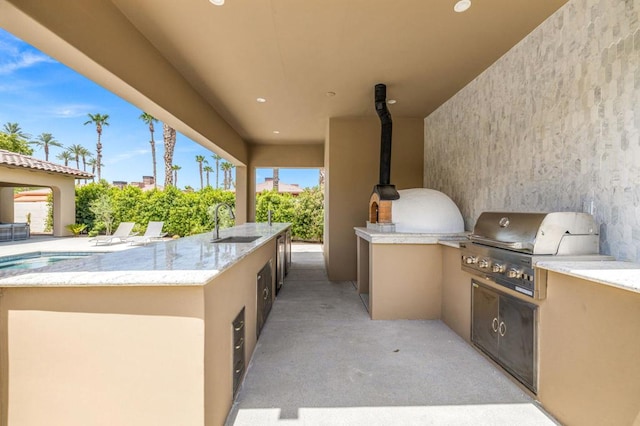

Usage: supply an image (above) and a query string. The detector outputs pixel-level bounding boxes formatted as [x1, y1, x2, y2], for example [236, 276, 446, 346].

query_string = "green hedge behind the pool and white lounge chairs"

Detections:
[69, 180, 324, 241]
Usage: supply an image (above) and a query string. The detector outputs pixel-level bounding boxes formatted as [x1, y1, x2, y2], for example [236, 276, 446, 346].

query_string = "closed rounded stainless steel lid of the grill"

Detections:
[469, 212, 599, 255]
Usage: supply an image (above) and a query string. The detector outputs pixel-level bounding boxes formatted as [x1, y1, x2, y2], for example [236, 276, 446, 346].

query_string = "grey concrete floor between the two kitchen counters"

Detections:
[227, 244, 556, 426]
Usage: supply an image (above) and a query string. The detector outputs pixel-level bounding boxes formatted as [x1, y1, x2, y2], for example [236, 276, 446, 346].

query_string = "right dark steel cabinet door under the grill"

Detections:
[498, 296, 536, 391]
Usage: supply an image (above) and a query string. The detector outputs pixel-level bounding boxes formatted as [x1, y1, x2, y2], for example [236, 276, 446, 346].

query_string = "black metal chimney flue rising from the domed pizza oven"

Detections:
[373, 84, 400, 200]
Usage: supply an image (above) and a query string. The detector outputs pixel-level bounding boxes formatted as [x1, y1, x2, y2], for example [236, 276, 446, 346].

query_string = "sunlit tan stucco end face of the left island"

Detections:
[0, 286, 205, 425]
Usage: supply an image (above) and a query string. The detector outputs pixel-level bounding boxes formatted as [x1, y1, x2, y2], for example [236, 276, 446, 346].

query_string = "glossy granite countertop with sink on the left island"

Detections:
[0, 223, 290, 287]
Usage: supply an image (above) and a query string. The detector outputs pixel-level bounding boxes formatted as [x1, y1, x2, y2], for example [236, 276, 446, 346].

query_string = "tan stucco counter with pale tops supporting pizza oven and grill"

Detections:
[356, 228, 640, 425]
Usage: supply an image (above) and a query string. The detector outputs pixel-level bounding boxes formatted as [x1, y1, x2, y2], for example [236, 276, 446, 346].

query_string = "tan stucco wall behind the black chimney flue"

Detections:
[324, 117, 423, 281]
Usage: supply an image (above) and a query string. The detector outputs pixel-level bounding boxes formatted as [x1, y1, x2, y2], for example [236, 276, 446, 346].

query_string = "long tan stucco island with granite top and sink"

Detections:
[0, 223, 290, 425]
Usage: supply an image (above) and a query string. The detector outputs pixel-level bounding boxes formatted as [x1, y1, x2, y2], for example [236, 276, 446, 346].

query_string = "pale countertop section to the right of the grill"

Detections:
[536, 260, 640, 293]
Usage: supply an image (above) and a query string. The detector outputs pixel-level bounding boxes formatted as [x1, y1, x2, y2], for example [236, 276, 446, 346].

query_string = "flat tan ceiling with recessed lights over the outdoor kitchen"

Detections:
[112, 0, 567, 144]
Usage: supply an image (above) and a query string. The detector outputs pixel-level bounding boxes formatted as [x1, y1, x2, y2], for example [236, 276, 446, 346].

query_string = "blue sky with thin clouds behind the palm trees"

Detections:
[0, 29, 318, 189]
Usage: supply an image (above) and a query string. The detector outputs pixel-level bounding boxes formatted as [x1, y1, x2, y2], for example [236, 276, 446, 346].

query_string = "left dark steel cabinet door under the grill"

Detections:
[471, 281, 500, 359]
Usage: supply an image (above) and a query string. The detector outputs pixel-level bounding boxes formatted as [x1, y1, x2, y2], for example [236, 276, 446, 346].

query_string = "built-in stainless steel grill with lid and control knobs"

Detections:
[461, 212, 611, 299]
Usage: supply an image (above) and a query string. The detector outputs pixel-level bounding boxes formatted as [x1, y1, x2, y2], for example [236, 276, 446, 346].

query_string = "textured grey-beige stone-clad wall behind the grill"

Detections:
[424, 0, 640, 262]
